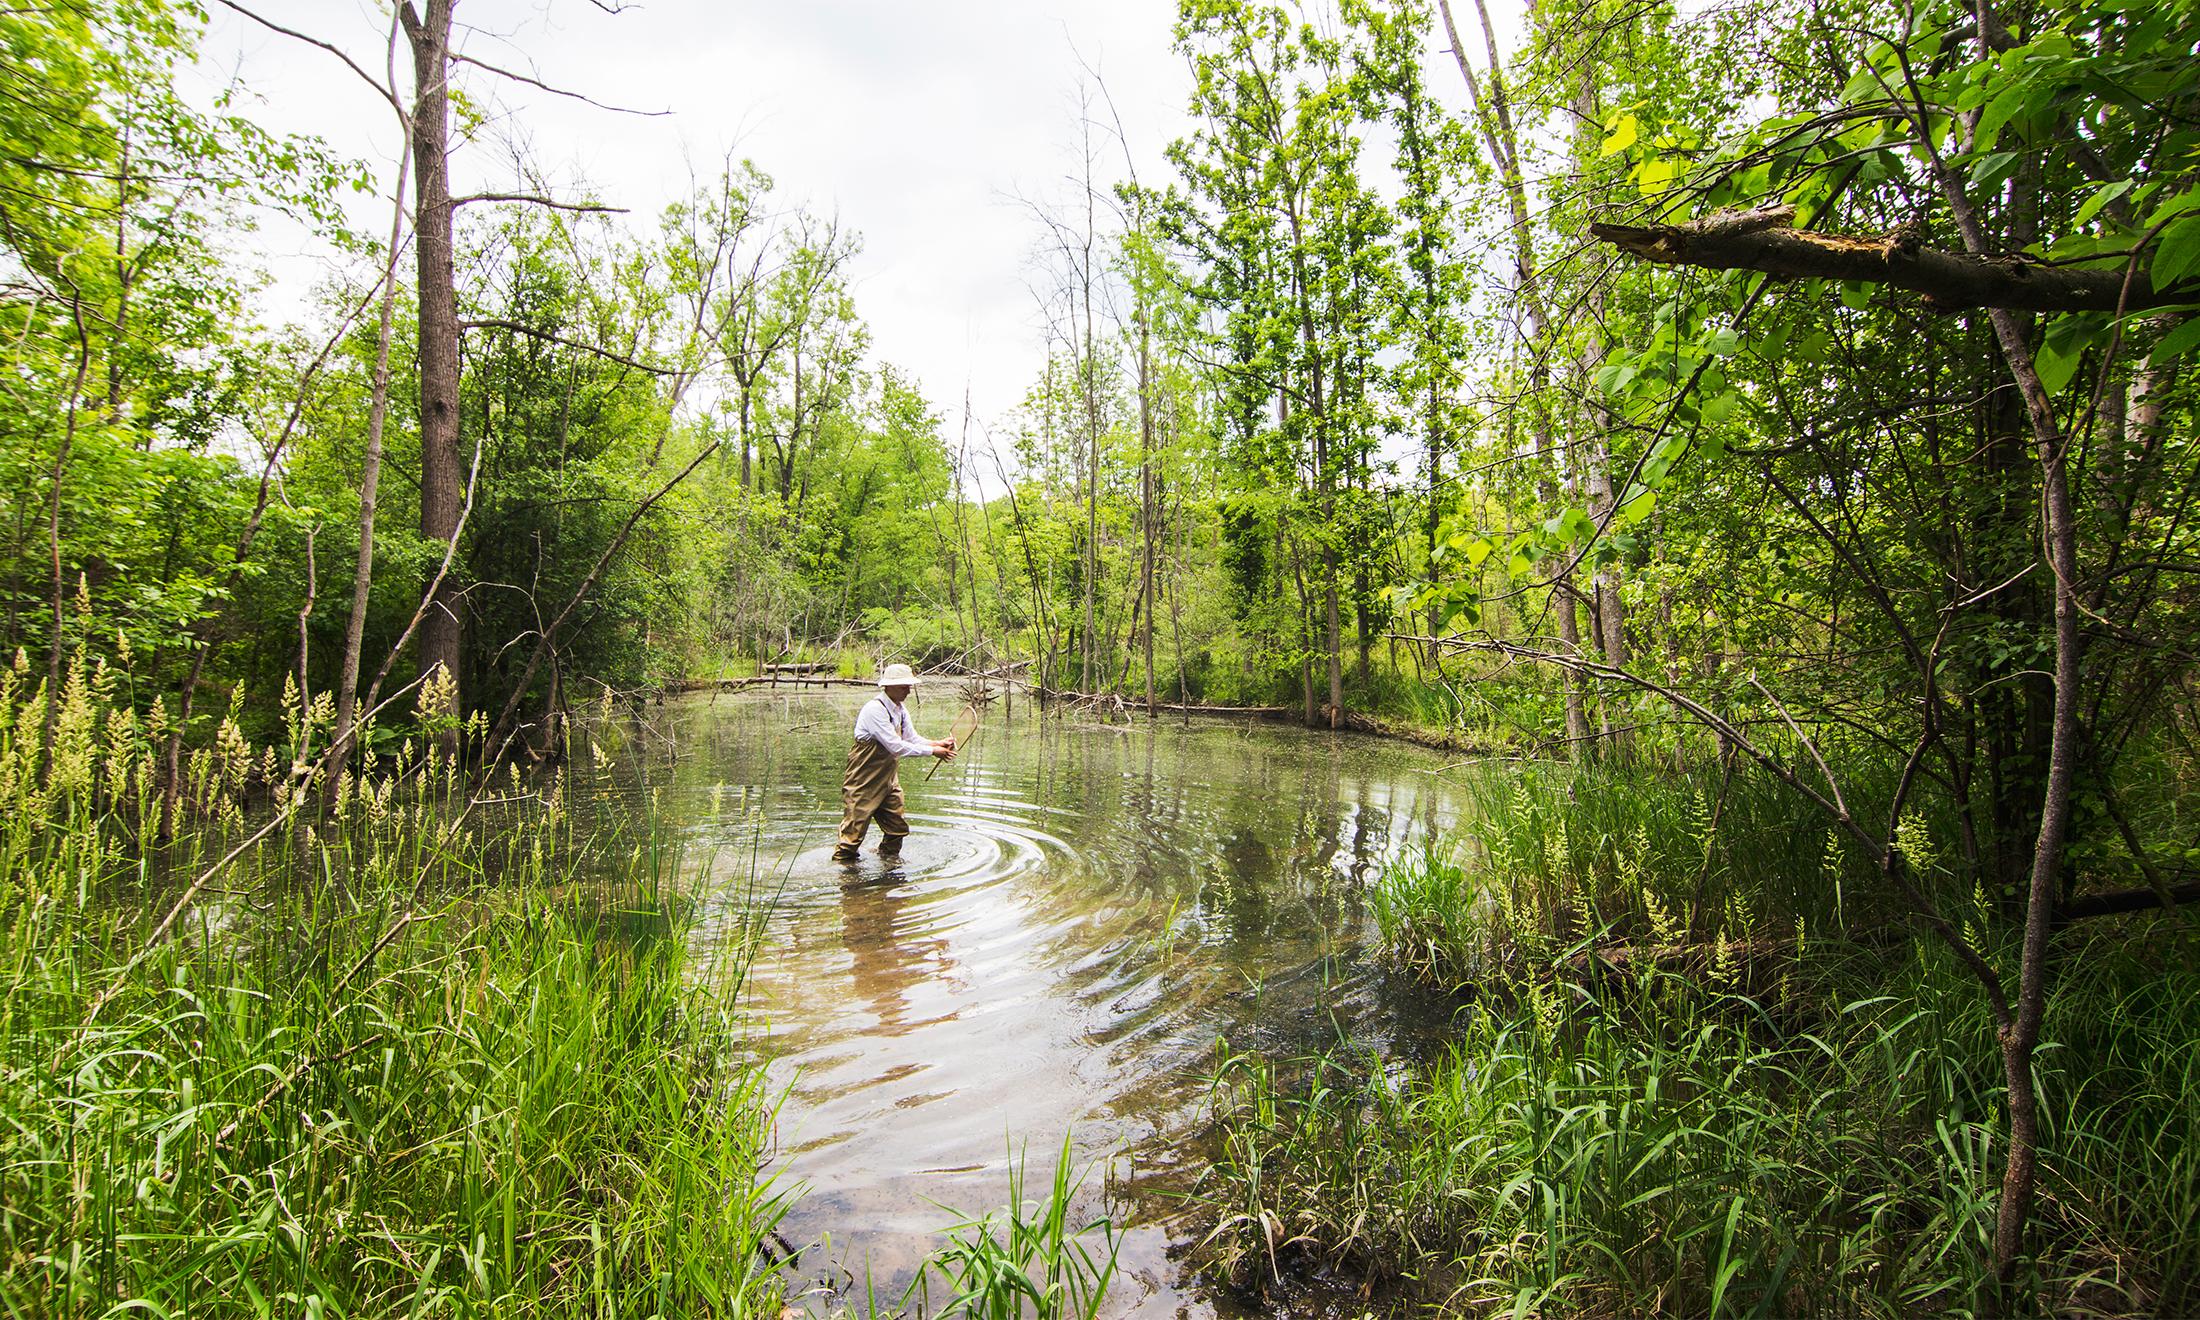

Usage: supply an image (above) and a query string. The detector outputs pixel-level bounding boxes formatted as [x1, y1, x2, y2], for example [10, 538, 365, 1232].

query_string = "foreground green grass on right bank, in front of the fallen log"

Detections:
[1201, 942, 2200, 1316]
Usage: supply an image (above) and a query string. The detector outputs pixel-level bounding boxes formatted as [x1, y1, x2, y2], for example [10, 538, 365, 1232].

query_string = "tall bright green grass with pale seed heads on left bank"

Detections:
[0, 664, 785, 1316]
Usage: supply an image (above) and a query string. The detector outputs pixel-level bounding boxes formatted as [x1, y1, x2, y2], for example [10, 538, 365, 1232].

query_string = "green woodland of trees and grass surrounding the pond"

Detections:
[0, 0, 2200, 1316]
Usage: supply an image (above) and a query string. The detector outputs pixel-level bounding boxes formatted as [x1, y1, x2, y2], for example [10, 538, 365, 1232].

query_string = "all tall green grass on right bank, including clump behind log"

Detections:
[1199, 768, 2200, 1316]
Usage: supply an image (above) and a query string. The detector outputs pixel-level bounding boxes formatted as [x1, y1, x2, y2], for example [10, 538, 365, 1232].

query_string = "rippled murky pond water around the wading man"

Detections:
[598, 684, 1467, 1316]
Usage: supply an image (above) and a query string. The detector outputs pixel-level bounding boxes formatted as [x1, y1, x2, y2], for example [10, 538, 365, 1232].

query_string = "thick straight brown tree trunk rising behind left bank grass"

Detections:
[398, 0, 464, 748]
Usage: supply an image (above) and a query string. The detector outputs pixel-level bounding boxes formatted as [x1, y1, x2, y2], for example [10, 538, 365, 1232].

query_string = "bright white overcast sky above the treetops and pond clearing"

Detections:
[205, 0, 1223, 444]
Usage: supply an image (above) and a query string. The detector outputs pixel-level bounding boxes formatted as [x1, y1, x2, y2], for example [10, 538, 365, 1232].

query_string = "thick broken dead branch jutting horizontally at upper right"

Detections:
[1588, 207, 2180, 312]
